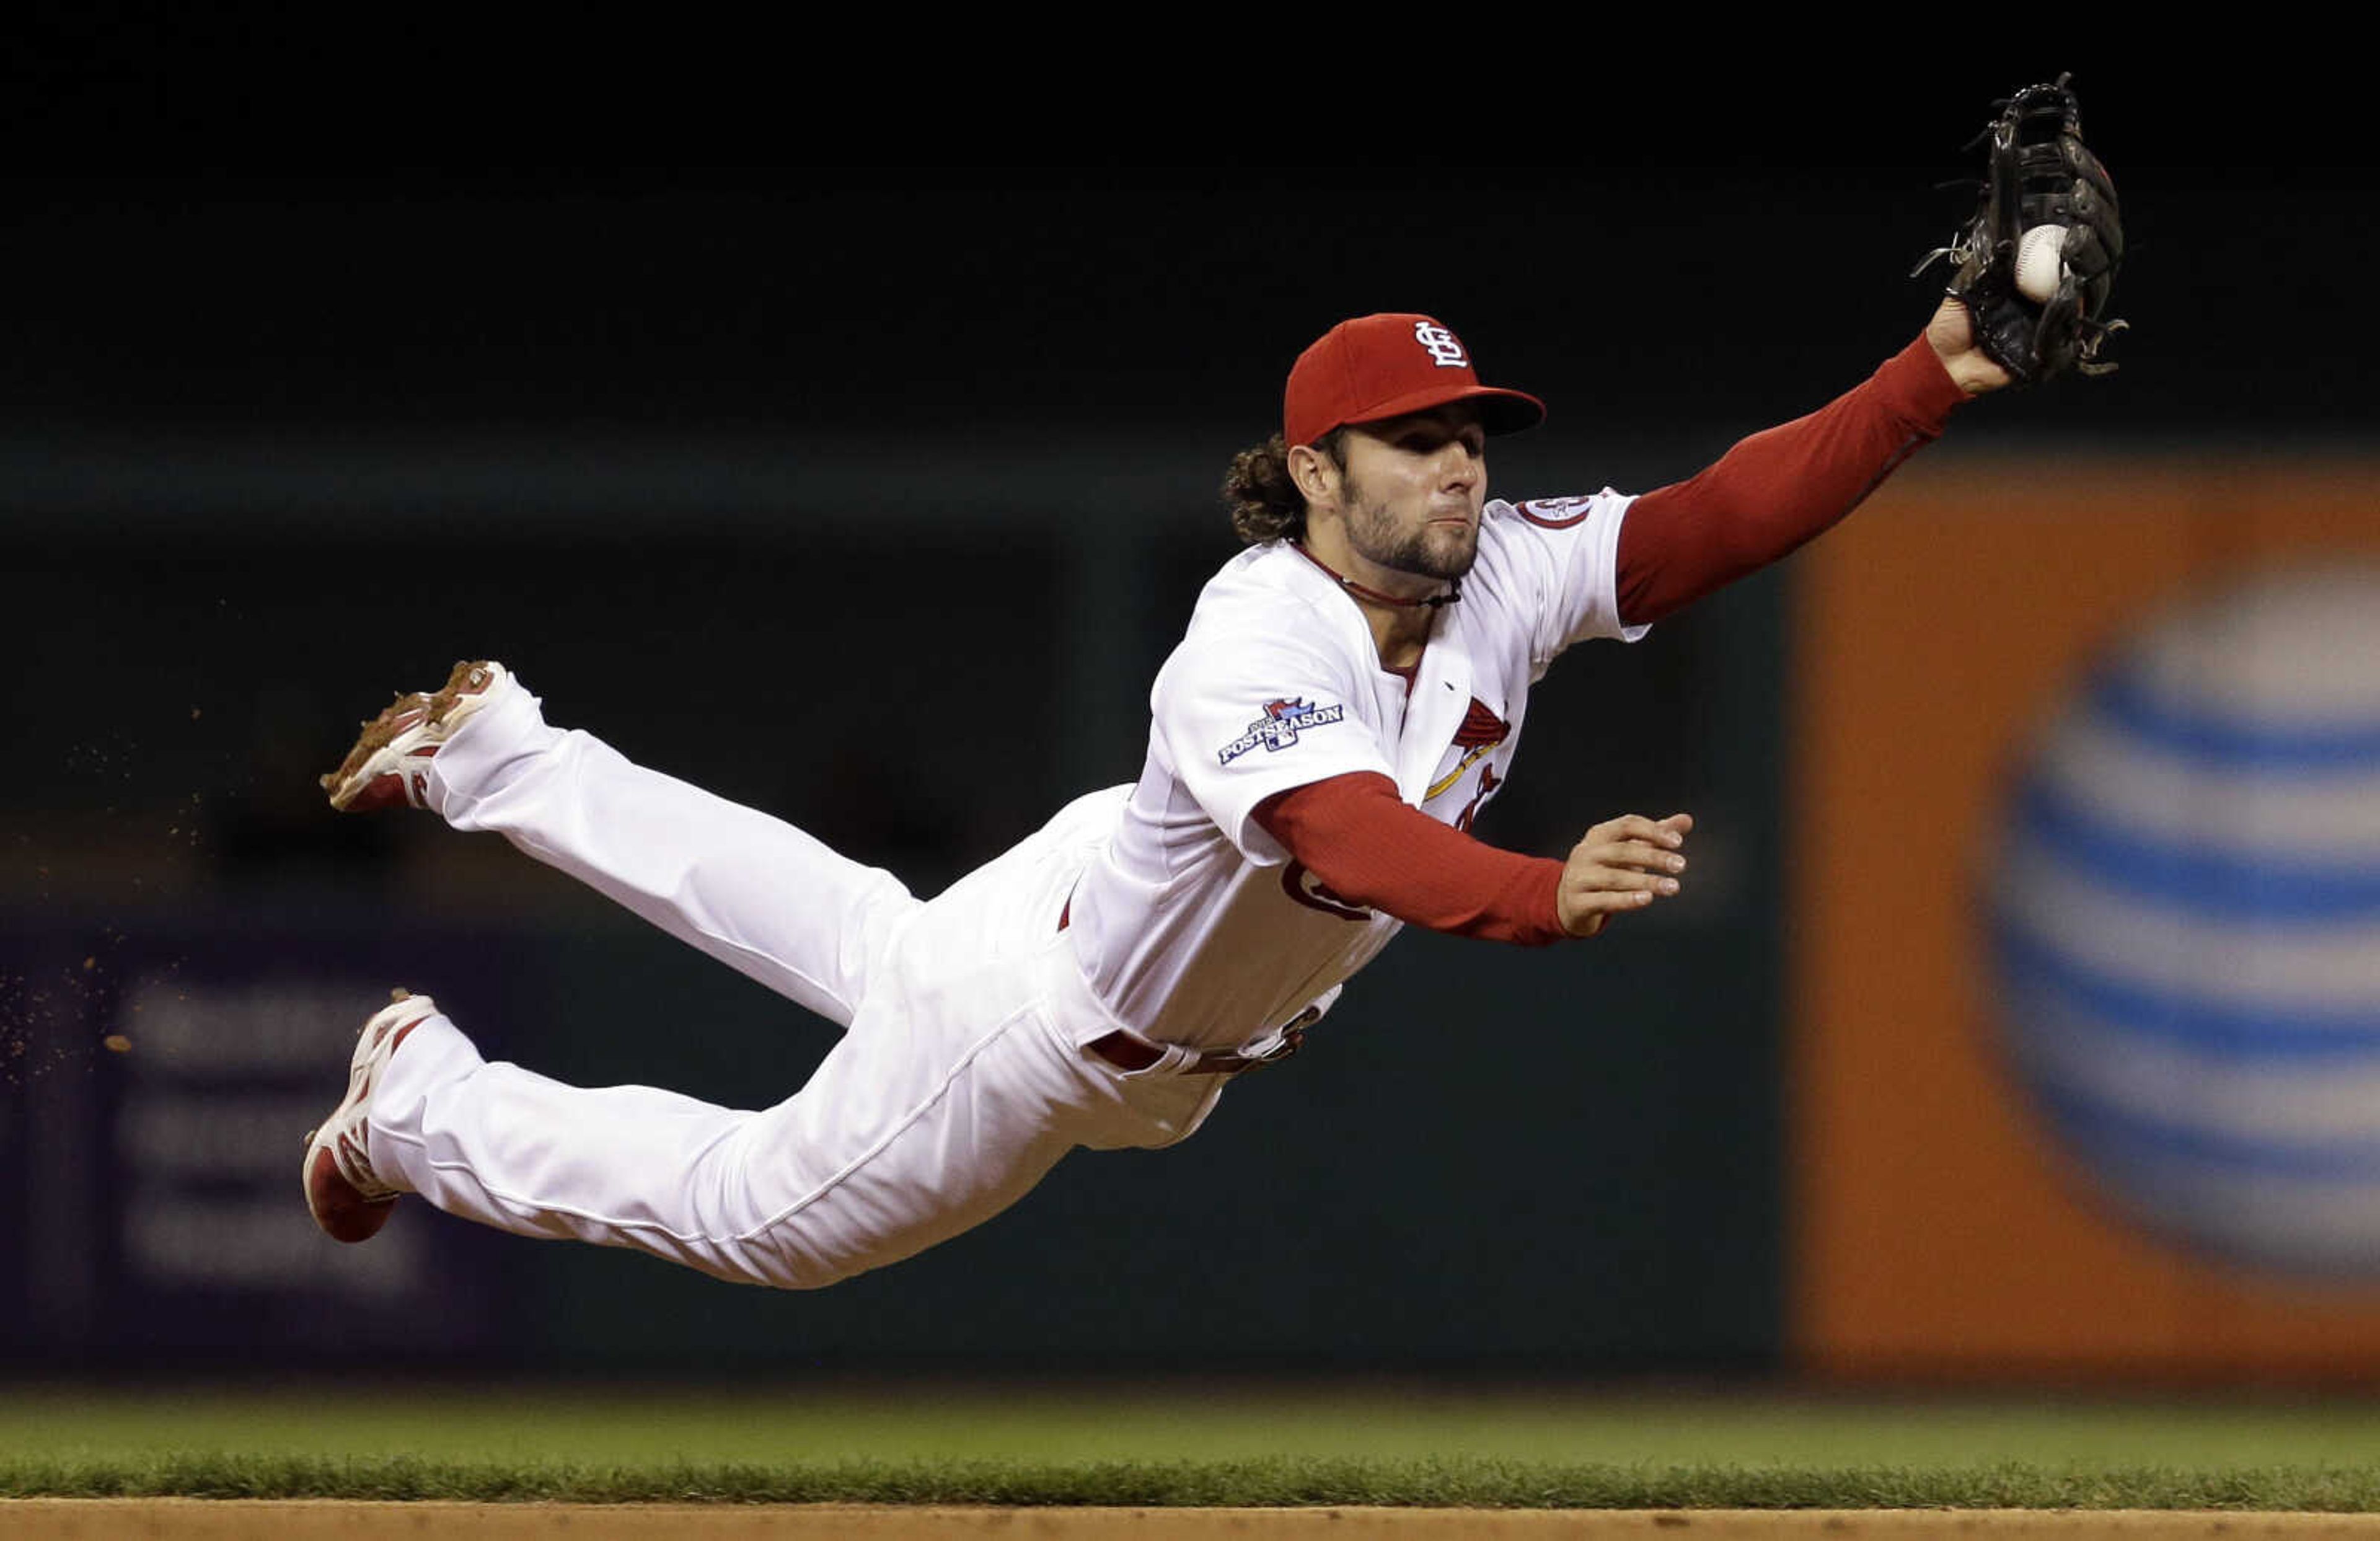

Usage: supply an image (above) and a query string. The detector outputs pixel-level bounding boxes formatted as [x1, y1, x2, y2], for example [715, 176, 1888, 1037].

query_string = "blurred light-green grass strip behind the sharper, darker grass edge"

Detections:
[14, 1386, 2380, 1470]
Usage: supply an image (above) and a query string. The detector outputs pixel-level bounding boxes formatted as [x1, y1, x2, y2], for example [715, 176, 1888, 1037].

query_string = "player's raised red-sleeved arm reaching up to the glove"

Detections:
[1618, 300, 2009, 627]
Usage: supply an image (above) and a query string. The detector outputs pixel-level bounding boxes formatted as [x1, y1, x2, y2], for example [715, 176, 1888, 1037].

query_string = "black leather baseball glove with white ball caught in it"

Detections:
[1911, 74, 2123, 384]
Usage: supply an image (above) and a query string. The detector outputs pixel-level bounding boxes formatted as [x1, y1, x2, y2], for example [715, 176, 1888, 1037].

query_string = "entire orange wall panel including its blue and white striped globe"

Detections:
[1787, 453, 2380, 1384]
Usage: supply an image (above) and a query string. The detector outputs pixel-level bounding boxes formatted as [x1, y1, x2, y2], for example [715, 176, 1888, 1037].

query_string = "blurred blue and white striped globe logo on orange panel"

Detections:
[1985, 567, 2380, 1279]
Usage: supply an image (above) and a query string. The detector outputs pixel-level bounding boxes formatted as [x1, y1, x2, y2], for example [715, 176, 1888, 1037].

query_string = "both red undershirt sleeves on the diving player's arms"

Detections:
[1257, 336, 1966, 945]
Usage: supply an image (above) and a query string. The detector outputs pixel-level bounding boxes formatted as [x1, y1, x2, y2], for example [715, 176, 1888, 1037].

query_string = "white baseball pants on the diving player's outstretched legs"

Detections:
[369, 679, 1221, 1289]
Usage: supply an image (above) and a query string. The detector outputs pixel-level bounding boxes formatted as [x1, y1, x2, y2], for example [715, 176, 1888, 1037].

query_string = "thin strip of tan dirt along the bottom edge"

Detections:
[14, 1498, 2380, 1541]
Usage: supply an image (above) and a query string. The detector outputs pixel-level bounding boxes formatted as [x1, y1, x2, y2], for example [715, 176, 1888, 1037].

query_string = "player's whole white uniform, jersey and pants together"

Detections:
[369, 491, 1635, 1289]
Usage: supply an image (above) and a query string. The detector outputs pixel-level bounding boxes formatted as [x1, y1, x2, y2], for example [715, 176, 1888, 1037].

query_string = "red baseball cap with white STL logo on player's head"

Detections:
[1280, 312, 1545, 443]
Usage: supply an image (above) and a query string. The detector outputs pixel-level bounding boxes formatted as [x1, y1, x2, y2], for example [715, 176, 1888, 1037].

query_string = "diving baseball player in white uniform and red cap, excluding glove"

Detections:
[302, 300, 2009, 1289]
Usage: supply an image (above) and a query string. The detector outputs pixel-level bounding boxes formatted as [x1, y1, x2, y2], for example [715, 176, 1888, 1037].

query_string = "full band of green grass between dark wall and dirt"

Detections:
[0, 1384, 2380, 1510]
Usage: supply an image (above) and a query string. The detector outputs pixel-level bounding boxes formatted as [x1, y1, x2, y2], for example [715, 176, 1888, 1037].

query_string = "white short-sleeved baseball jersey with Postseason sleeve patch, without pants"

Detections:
[1071, 488, 1644, 1048]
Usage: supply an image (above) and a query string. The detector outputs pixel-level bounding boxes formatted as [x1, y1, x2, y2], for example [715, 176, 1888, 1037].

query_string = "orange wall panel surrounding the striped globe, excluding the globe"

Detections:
[1787, 453, 2380, 1384]
